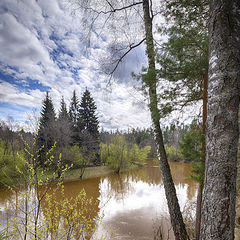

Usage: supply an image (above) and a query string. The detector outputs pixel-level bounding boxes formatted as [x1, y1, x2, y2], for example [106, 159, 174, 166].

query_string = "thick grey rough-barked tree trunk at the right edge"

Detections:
[200, 0, 240, 240]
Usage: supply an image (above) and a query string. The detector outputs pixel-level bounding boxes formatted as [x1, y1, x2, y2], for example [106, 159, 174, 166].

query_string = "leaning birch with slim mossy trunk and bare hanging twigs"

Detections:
[71, 0, 188, 240]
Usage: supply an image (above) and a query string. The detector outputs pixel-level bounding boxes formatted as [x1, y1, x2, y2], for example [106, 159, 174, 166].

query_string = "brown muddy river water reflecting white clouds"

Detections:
[0, 161, 197, 240]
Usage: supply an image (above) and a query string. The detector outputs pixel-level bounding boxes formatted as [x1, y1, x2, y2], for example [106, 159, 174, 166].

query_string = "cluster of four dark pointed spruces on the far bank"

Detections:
[36, 89, 100, 172]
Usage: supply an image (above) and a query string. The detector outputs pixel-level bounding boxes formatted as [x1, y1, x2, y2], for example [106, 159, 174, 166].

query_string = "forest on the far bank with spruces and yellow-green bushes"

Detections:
[0, 89, 203, 187]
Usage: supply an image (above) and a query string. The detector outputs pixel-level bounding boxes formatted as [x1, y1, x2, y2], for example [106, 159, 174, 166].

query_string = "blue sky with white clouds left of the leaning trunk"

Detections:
[0, 0, 154, 130]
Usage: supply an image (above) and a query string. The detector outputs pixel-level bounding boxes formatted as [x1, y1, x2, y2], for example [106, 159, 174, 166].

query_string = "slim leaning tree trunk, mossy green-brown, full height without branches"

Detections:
[143, 0, 188, 240]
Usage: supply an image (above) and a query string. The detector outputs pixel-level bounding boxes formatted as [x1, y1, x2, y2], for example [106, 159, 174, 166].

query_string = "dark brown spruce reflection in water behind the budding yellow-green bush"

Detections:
[40, 178, 100, 240]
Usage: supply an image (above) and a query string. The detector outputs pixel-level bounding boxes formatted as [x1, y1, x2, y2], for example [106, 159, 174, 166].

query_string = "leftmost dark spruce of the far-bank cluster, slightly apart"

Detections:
[37, 92, 56, 166]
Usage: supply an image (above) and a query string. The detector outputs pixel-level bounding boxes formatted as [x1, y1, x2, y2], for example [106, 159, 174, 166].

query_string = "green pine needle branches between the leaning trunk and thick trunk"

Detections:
[157, 0, 209, 114]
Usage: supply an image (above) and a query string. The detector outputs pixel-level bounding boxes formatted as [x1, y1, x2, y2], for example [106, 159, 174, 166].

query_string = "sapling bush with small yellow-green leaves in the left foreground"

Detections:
[1, 135, 104, 240]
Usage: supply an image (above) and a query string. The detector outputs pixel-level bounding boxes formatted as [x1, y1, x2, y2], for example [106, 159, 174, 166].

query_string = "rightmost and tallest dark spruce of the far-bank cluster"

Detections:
[79, 89, 100, 164]
